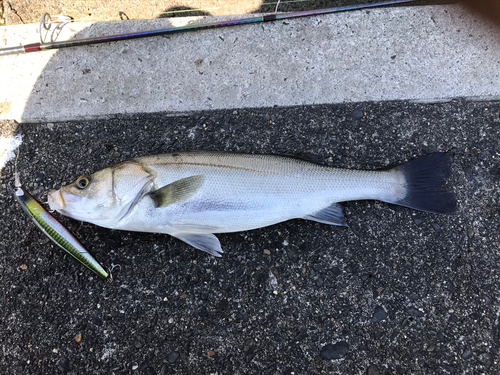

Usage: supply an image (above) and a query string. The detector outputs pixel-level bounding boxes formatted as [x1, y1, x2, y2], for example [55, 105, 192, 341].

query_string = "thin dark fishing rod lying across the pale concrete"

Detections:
[0, 0, 416, 56]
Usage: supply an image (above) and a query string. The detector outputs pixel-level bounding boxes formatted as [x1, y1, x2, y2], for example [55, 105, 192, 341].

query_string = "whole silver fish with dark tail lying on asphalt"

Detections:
[47, 151, 456, 257]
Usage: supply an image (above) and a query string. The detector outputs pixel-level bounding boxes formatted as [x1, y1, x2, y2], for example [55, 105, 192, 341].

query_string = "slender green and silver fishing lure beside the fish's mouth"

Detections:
[14, 171, 109, 279]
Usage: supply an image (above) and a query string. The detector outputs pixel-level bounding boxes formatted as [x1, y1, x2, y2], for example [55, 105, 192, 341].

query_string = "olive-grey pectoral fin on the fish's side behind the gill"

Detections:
[149, 175, 205, 208]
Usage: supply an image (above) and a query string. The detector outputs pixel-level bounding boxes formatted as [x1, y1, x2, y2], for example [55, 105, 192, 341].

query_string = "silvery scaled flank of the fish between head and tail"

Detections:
[133, 154, 390, 233]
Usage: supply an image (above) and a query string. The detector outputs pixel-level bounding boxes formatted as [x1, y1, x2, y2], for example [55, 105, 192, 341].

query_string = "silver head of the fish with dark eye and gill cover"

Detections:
[47, 161, 153, 228]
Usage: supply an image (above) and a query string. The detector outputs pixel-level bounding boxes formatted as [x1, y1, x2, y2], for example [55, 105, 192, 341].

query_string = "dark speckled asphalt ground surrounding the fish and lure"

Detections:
[0, 100, 500, 375]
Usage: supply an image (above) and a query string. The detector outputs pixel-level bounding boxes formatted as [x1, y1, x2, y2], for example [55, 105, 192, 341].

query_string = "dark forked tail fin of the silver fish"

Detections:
[390, 152, 457, 214]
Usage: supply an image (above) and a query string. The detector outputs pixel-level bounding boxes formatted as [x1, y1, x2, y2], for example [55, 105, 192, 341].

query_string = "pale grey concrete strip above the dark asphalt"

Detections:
[0, 6, 500, 122]
